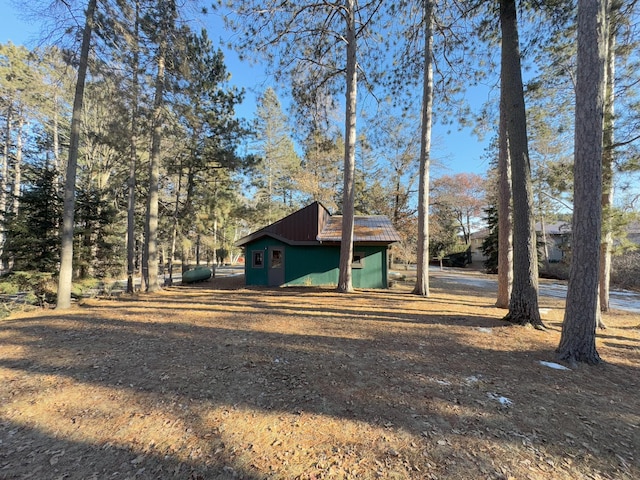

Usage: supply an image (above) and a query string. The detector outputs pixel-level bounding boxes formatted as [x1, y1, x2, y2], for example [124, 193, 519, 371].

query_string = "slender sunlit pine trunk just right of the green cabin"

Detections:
[413, 0, 433, 297]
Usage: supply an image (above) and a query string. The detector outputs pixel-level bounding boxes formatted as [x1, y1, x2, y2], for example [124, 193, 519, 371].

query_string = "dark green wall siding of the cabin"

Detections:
[245, 237, 388, 288]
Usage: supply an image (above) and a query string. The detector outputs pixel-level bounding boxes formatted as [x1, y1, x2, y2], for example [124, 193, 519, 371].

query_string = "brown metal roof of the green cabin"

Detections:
[235, 202, 401, 247]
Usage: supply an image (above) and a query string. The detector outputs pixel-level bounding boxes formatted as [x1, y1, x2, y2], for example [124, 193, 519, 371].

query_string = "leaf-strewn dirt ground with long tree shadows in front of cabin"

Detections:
[0, 272, 640, 480]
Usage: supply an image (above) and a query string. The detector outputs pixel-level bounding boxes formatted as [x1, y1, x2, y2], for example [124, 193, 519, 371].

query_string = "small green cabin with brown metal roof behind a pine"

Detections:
[236, 202, 400, 288]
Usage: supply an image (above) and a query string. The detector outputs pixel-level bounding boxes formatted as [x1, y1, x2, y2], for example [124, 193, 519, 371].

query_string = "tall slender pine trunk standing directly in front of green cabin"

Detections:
[338, 0, 358, 293]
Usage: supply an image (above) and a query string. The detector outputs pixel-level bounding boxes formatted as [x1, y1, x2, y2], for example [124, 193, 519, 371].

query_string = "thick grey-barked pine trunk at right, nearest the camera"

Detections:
[557, 0, 607, 364]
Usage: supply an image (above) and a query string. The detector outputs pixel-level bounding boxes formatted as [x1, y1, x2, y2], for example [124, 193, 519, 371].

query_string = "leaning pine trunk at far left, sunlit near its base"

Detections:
[56, 0, 96, 310]
